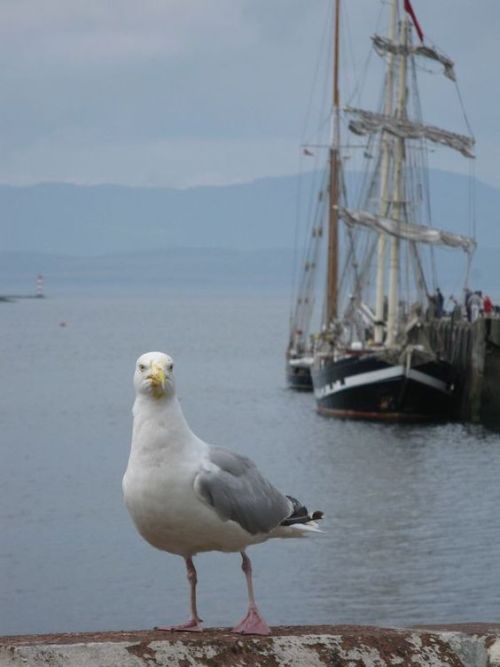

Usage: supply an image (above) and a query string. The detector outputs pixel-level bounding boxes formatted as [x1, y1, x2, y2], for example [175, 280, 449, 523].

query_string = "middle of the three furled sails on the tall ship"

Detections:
[346, 107, 475, 158]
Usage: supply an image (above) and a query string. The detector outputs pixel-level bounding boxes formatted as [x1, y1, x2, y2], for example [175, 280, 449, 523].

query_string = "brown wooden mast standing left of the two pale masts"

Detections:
[325, 0, 340, 326]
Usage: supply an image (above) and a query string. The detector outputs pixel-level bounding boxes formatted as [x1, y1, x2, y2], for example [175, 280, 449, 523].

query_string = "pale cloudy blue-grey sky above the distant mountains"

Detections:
[0, 0, 500, 188]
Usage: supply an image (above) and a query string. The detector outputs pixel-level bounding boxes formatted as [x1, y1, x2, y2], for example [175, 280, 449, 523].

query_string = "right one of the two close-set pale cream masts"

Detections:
[387, 11, 408, 347]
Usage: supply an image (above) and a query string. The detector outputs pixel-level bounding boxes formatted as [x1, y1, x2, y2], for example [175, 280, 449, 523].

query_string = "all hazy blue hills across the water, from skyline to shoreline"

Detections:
[0, 171, 500, 299]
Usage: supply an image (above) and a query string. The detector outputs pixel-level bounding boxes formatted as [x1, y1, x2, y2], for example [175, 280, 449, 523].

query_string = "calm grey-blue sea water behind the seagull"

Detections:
[0, 295, 500, 634]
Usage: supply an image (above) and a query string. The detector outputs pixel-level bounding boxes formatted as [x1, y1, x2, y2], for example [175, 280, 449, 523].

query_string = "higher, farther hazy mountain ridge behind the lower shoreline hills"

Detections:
[0, 171, 500, 256]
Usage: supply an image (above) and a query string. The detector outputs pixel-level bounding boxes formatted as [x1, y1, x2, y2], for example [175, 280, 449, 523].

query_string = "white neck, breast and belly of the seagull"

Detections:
[123, 397, 265, 556]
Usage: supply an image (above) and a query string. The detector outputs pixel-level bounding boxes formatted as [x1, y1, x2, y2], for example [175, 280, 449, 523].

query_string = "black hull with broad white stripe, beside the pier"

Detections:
[312, 353, 454, 421]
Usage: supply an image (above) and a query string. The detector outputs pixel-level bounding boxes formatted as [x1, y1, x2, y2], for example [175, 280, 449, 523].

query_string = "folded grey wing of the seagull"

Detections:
[195, 447, 292, 535]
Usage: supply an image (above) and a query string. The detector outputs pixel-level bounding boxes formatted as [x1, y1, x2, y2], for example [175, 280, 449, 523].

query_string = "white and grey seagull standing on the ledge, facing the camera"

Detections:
[123, 352, 323, 635]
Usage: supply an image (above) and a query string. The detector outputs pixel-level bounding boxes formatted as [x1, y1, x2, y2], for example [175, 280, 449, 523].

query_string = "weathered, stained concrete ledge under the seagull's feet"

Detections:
[0, 623, 500, 667]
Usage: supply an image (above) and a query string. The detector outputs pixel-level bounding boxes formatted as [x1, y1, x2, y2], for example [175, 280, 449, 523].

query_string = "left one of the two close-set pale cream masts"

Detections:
[374, 1, 398, 344]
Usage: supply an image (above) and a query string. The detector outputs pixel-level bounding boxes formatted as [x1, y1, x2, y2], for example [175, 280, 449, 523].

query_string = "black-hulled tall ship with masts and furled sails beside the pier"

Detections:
[287, 0, 475, 421]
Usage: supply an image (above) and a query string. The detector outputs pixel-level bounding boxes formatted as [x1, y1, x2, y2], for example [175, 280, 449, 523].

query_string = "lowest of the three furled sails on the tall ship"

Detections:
[339, 208, 476, 253]
